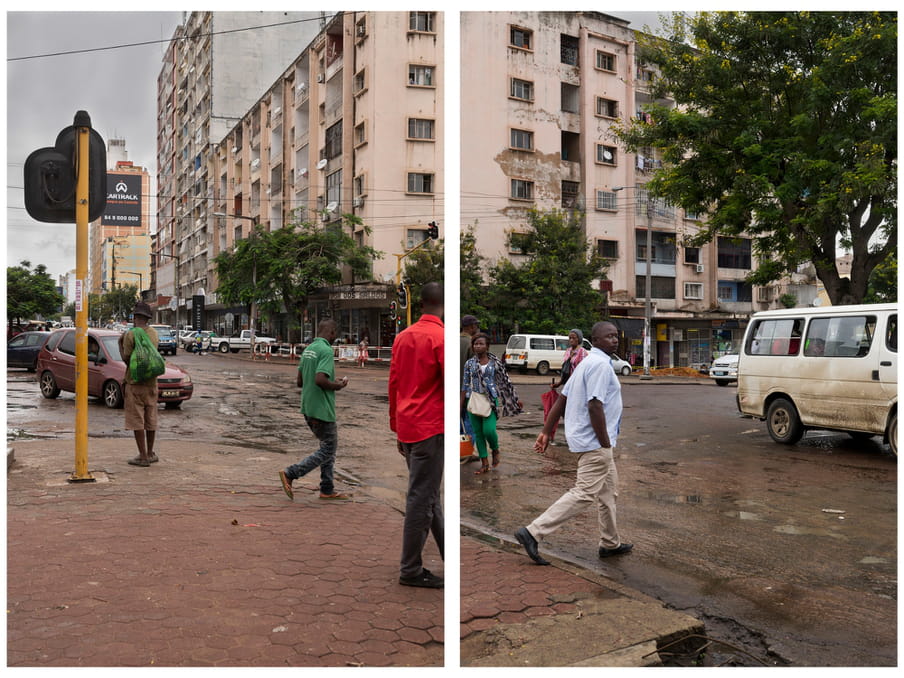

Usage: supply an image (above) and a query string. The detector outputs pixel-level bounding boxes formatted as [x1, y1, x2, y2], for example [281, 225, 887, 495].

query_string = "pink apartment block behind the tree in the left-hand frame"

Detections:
[205, 12, 444, 345]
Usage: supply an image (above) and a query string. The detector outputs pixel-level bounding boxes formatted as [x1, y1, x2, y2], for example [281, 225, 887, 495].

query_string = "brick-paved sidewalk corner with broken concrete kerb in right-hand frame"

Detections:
[460, 530, 704, 667]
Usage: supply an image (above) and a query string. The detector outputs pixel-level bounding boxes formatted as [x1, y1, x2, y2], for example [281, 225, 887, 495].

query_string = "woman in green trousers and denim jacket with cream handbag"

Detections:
[460, 334, 521, 475]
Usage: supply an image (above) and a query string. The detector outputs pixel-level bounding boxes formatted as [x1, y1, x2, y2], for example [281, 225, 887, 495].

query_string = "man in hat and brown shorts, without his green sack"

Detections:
[119, 301, 158, 466]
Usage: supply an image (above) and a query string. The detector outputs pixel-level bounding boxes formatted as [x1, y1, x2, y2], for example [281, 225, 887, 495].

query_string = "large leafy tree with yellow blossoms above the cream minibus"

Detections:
[617, 12, 897, 304]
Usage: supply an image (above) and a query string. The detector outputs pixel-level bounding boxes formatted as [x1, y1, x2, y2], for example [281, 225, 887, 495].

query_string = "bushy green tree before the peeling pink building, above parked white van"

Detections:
[481, 210, 606, 333]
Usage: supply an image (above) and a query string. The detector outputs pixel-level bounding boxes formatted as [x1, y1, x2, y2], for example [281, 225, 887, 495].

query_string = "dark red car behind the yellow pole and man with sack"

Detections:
[37, 329, 194, 409]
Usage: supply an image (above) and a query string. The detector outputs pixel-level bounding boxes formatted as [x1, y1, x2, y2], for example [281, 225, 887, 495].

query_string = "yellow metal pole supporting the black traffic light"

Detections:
[69, 127, 94, 483]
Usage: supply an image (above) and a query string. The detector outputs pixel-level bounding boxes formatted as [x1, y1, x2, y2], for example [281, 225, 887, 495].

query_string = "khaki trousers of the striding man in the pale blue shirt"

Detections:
[527, 447, 621, 549]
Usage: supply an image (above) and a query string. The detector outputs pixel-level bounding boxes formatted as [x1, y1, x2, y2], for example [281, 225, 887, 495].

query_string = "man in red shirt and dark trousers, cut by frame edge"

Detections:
[389, 283, 445, 589]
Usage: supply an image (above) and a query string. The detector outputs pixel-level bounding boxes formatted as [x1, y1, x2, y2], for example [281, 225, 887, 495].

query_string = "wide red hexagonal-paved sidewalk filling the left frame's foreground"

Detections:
[7, 436, 444, 667]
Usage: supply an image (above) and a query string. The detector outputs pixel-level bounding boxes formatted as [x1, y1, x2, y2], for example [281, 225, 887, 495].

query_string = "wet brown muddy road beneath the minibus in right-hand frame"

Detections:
[461, 376, 897, 666]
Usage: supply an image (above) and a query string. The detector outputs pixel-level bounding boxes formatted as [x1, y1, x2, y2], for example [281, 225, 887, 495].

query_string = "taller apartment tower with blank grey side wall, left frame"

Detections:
[151, 12, 329, 325]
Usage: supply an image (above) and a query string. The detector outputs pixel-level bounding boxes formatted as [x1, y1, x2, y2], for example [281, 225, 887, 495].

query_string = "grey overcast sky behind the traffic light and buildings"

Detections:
[5, 12, 659, 280]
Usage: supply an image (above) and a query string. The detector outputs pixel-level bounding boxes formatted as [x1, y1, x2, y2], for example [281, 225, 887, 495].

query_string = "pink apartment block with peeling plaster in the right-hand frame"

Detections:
[461, 12, 771, 366]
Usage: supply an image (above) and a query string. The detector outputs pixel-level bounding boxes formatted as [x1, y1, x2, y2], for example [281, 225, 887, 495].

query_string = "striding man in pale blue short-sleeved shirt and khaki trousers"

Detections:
[515, 321, 634, 565]
